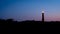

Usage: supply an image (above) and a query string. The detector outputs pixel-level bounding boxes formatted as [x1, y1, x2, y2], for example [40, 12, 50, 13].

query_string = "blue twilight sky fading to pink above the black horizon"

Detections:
[0, 0, 60, 21]
